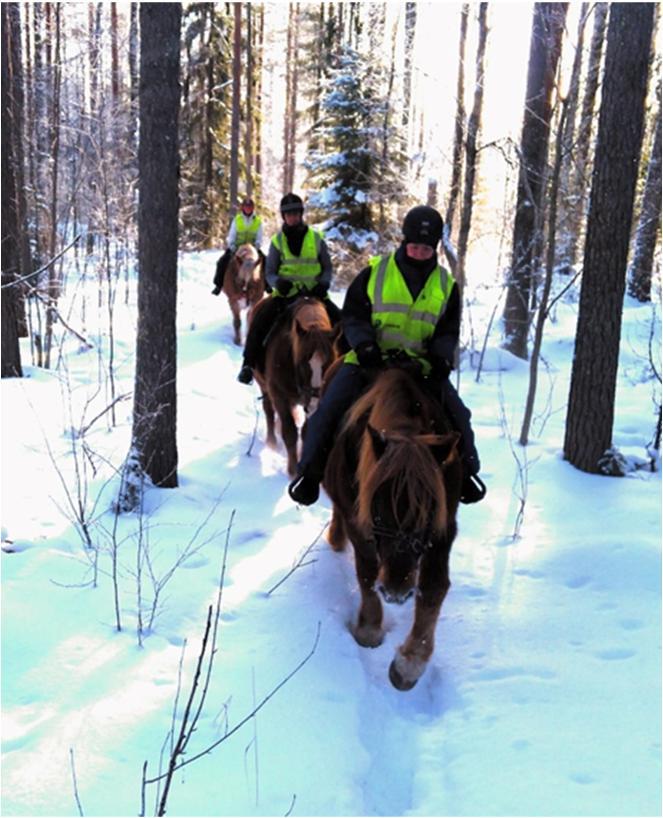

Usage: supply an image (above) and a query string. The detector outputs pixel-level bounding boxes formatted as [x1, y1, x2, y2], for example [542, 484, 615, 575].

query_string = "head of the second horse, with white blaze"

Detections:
[290, 298, 336, 414]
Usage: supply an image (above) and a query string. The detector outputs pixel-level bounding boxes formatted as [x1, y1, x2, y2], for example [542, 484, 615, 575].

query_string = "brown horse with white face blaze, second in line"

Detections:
[252, 298, 338, 477]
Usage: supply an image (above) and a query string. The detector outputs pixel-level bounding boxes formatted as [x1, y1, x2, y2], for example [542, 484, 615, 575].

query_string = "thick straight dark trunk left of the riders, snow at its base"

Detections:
[132, 3, 182, 488]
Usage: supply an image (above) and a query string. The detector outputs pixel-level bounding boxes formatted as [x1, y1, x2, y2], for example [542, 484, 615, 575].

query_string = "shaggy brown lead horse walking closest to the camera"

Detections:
[324, 369, 462, 690]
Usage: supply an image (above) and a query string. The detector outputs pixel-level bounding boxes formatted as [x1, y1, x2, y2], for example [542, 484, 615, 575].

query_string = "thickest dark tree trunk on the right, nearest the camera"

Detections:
[564, 3, 654, 474]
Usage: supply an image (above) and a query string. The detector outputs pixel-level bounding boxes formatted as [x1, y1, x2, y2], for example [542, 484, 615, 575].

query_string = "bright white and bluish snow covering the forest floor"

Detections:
[2, 253, 661, 816]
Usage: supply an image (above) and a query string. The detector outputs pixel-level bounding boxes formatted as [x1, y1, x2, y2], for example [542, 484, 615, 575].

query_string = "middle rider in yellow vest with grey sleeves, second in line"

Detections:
[237, 193, 341, 384]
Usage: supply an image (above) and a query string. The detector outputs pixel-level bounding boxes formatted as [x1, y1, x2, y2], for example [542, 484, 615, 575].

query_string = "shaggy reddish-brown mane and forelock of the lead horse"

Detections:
[346, 369, 454, 533]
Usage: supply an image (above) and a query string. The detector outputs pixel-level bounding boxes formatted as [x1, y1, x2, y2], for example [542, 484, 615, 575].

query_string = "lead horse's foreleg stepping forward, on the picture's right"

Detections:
[389, 547, 451, 690]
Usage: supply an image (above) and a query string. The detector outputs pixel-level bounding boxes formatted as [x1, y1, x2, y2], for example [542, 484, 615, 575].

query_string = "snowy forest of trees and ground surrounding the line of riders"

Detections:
[1, 0, 661, 815]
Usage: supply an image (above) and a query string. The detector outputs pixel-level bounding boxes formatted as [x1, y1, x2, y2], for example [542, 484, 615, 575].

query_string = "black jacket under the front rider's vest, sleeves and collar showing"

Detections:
[342, 245, 460, 365]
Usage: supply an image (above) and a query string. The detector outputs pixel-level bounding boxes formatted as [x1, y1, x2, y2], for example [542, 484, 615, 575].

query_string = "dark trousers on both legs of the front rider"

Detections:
[298, 364, 480, 480]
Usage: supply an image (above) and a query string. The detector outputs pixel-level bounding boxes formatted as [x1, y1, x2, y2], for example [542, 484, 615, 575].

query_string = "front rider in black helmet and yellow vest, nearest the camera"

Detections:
[288, 205, 486, 505]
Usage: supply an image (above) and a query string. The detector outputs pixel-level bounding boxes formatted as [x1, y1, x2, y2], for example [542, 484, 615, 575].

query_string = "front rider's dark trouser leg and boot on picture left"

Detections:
[288, 364, 366, 506]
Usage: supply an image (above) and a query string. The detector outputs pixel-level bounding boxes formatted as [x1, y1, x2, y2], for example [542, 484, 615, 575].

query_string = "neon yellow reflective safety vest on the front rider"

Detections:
[345, 253, 455, 375]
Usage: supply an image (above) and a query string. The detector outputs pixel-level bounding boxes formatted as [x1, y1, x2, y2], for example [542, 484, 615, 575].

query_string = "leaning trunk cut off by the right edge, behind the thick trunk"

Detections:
[628, 94, 661, 301]
